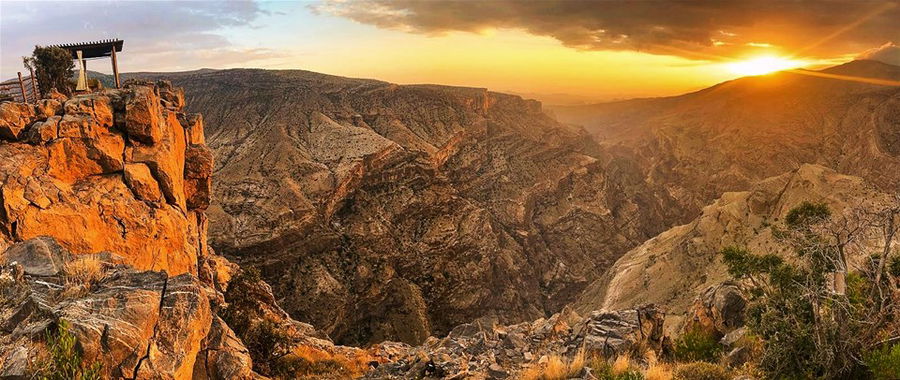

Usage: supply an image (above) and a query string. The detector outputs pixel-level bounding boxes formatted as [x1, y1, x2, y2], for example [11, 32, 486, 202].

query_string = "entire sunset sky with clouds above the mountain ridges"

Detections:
[0, 0, 900, 103]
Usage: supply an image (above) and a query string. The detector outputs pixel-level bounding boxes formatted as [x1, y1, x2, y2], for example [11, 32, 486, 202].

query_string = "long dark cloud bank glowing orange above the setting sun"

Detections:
[312, 0, 900, 59]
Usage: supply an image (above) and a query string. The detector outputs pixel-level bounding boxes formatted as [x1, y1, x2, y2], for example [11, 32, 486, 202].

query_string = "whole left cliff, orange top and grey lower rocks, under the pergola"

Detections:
[0, 82, 378, 379]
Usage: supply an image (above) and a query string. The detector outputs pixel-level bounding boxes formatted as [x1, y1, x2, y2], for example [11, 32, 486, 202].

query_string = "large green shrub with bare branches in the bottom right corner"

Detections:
[722, 202, 898, 379]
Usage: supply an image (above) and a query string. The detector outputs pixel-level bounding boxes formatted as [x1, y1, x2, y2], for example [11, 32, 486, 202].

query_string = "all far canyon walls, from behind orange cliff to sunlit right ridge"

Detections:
[135, 61, 900, 344]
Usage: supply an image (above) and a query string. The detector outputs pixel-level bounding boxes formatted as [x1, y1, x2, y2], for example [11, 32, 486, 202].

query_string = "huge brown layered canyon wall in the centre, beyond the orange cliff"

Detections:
[128, 70, 679, 344]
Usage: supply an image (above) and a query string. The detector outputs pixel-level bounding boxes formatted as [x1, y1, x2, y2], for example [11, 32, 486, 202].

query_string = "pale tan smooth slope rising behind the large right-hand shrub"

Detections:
[573, 164, 896, 335]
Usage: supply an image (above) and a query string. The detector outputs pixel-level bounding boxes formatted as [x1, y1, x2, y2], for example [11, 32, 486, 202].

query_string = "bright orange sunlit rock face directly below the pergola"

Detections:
[0, 83, 212, 275]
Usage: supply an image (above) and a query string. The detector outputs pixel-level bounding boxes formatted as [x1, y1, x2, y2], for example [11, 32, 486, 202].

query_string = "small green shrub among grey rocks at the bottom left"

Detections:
[36, 321, 103, 380]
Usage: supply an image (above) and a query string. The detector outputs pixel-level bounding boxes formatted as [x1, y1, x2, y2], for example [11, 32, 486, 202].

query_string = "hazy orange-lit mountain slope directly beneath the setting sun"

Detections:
[553, 61, 900, 218]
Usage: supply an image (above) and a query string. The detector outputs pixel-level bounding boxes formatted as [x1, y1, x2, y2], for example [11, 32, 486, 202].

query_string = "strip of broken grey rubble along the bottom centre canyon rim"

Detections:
[366, 305, 668, 379]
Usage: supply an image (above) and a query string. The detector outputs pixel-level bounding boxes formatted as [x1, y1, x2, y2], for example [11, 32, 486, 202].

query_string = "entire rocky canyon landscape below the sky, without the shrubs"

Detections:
[0, 61, 900, 379]
